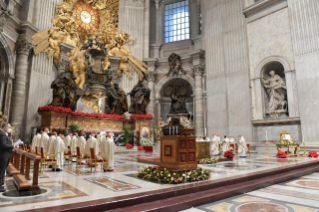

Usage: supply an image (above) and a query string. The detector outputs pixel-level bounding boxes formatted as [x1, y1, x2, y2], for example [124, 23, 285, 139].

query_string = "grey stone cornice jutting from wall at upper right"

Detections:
[243, 0, 288, 23]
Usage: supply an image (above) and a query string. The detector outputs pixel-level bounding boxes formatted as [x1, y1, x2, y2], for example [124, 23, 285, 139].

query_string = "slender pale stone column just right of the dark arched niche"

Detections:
[193, 65, 205, 136]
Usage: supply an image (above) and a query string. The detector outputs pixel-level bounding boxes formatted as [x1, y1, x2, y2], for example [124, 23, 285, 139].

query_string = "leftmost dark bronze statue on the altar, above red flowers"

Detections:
[50, 71, 77, 110]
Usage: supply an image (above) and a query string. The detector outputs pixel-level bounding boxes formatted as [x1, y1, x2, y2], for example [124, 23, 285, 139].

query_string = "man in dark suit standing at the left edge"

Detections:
[0, 123, 14, 192]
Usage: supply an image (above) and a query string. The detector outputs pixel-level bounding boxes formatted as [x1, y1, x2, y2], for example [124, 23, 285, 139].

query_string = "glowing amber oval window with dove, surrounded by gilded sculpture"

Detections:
[74, 0, 99, 33]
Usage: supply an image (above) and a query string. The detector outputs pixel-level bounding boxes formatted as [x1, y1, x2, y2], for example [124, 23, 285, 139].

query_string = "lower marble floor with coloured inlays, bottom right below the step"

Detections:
[181, 172, 319, 212]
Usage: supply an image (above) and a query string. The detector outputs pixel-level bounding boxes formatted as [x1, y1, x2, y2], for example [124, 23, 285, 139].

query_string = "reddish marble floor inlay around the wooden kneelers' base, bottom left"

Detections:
[0, 181, 88, 208]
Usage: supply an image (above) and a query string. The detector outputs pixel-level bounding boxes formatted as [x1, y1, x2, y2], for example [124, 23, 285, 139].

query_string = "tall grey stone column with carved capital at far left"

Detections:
[10, 39, 33, 137]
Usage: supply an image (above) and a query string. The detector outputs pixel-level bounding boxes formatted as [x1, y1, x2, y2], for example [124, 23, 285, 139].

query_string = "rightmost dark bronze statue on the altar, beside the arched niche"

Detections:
[129, 80, 151, 114]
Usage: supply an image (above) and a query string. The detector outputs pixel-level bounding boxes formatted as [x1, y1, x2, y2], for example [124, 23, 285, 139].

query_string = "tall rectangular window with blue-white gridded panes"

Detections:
[165, 0, 190, 43]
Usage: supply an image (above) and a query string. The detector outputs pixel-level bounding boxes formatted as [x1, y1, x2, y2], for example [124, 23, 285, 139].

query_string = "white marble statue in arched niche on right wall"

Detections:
[261, 70, 287, 118]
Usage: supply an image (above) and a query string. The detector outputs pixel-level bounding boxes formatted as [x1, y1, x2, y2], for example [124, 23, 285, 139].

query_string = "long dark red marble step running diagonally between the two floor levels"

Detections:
[108, 165, 319, 212]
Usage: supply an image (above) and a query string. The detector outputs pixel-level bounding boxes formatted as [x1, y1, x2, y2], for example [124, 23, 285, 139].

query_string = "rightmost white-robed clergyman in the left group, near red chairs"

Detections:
[101, 133, 116, 172]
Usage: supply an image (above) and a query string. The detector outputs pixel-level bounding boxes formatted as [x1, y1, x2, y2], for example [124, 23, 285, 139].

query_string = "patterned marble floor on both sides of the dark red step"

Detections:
[0, 148, 319, 212]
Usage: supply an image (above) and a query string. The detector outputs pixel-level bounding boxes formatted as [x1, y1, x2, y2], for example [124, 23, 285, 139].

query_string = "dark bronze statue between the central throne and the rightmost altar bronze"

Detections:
[108, 84, 128, 115]
